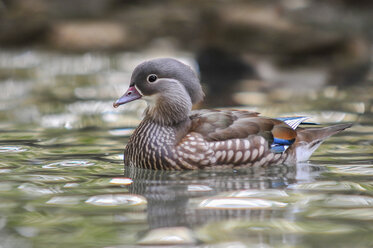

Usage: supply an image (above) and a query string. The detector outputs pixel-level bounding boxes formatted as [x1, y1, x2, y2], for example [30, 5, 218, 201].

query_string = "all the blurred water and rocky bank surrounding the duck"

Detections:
[0, 0, 373, 248]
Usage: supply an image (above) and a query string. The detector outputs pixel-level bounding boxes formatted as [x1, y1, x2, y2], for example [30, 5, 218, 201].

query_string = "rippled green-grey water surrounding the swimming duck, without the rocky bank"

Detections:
[0, 51, 373, 248]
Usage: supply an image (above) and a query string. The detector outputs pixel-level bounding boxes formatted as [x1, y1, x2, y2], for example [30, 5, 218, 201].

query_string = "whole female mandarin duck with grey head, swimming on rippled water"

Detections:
[113, 58, 351, 170]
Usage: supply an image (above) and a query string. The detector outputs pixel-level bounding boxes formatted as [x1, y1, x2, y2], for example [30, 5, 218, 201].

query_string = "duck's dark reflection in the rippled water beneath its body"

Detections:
[125, 165, 317, 229]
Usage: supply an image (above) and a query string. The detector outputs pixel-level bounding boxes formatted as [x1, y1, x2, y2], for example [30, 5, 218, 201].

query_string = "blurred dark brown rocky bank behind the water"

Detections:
[0, 0, 373, 106]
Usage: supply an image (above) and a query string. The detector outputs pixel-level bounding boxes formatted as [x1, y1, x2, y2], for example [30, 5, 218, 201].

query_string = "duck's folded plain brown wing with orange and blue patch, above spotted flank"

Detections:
[190, 110, 296, 145]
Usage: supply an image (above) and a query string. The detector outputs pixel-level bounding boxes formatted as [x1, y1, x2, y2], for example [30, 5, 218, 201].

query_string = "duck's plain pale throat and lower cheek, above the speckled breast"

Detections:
[145, 84, 192, 126]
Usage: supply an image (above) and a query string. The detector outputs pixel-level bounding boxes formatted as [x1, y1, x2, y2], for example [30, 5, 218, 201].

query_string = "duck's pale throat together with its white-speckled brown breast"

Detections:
[124, 84, 192, 169]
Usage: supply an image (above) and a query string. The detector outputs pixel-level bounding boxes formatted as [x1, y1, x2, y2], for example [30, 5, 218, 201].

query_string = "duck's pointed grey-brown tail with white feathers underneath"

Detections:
[286, 123, 352, 163]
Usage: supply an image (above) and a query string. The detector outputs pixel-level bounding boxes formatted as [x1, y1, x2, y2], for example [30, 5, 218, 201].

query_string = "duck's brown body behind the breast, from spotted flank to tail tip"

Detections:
[176, 110, 351, 169]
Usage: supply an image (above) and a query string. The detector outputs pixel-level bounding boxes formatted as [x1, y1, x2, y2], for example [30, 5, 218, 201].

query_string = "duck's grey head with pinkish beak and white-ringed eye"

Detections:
[113, 58, 204, 124]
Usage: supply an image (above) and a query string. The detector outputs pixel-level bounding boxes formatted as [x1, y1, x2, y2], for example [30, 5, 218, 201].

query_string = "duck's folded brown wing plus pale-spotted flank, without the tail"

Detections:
[166, 110, 296, 169]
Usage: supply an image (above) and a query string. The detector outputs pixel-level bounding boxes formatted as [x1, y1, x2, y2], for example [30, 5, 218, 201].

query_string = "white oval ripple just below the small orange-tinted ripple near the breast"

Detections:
[85, 194, 147, 206]
